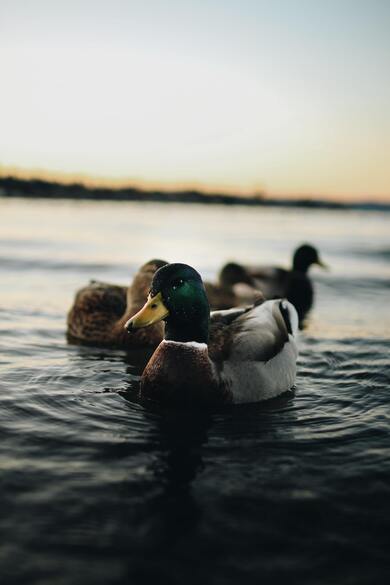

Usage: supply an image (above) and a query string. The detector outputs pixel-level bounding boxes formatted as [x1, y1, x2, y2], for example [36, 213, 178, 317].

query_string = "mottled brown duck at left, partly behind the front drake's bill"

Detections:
[67, 260, 166, 348]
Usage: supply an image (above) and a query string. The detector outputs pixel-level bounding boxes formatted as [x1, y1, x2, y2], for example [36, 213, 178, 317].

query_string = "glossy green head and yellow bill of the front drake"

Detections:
[125, 264, 210, 343]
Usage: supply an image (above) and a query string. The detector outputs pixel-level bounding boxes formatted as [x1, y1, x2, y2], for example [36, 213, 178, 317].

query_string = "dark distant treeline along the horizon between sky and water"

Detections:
[0, 177, 390, 211]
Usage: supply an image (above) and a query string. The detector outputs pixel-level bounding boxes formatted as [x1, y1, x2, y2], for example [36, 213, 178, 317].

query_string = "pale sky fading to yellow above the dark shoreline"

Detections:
[0, 0, 390, 201]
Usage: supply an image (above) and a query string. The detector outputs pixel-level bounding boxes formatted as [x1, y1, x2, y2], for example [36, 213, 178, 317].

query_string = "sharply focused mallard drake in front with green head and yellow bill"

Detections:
[125, 264, 298, 404]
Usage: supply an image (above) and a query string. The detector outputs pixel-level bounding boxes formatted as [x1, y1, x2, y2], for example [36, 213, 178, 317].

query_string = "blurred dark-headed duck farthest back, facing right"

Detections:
[220, 244, 327, 327]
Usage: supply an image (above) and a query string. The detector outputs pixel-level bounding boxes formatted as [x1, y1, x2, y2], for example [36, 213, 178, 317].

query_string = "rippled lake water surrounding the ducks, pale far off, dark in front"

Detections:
[0, 199, 390, 585]
